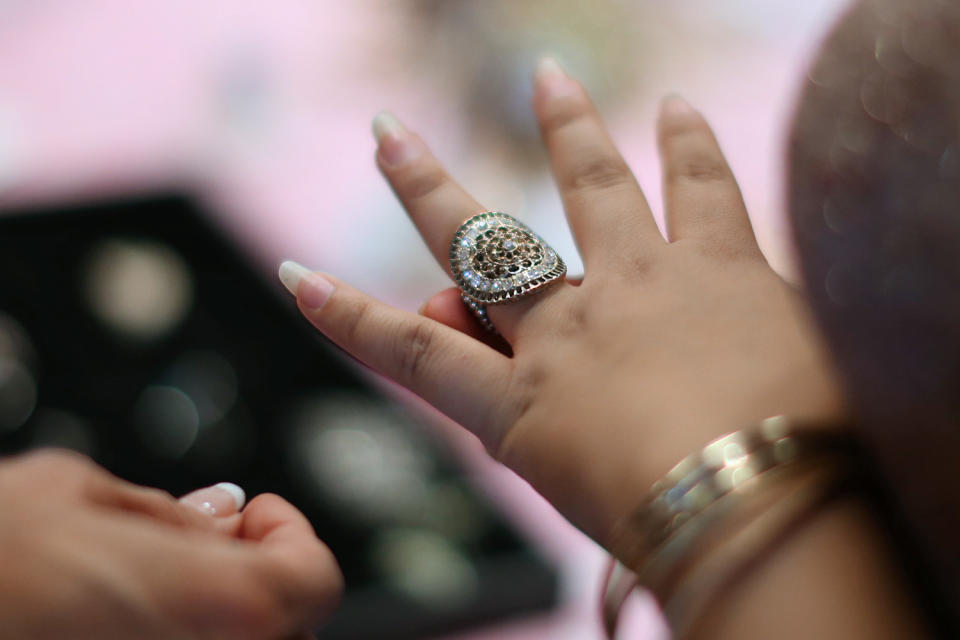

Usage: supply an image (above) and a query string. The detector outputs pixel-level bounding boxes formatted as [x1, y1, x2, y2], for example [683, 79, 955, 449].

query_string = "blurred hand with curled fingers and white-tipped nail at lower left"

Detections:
[0, 451, 342, 640]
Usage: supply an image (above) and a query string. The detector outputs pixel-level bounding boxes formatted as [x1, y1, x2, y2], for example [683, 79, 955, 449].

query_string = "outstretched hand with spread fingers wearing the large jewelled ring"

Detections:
[282, 61, 843, 551]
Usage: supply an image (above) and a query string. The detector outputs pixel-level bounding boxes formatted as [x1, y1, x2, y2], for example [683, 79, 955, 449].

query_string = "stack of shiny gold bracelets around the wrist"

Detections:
[603, 416, 859, 638]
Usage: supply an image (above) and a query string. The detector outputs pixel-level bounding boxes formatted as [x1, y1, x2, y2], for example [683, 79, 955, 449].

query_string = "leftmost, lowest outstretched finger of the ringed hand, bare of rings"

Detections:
[280, 262, 515, 448]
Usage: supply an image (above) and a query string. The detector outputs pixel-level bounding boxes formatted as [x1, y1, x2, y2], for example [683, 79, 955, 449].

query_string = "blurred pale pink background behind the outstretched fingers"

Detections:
[0, 0, 845, 640]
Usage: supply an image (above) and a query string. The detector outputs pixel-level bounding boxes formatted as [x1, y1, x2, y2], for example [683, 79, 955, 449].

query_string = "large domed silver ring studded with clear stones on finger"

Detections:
[450, 211, 567, 331]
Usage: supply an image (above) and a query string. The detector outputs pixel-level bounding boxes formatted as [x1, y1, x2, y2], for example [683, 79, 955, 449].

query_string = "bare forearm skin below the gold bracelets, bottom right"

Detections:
[684, 498, 932, 640]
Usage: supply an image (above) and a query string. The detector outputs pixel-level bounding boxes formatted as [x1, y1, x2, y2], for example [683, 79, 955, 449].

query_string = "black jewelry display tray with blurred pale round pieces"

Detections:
[0, 195, 557, 640]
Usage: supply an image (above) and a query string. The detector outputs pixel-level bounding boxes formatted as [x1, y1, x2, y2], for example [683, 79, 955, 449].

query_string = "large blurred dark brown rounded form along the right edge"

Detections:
[790, 0, 960, 610]
